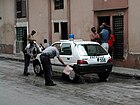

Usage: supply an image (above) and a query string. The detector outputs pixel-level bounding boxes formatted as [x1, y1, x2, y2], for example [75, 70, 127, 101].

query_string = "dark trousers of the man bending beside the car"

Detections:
[40, 55, 53, 84]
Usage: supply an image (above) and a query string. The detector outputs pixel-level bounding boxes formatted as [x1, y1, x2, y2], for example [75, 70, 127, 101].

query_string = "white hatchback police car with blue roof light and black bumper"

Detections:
[33, 39, 113, 80]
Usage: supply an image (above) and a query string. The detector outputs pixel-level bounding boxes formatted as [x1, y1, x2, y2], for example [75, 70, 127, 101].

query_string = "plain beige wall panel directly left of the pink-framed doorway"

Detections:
[70, 0, 94, 40]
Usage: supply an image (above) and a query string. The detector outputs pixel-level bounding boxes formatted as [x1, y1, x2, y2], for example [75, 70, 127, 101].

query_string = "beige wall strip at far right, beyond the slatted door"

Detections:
[128, 0, 140, 54]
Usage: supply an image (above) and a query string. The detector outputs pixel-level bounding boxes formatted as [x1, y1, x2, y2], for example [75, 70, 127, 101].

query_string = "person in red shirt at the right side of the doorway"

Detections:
[108, 30, 115, 57]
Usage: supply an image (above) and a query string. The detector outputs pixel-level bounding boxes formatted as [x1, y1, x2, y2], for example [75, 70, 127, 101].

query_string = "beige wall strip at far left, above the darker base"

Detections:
[0, 0, 15, 45]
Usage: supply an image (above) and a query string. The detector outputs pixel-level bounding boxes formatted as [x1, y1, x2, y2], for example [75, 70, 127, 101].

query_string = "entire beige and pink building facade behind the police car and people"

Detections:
[0, 0, 140, 68]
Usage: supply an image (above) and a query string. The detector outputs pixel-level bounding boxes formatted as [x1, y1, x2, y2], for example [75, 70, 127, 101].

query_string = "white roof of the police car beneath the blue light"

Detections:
[55, 39, 99, 44]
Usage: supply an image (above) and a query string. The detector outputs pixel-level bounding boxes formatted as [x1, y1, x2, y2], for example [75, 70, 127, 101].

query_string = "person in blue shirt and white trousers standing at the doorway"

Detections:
[100, 24, 109, 52]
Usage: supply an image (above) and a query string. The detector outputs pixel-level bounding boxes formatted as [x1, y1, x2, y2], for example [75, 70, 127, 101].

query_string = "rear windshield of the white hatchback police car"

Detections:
[77, 44, 108, 56]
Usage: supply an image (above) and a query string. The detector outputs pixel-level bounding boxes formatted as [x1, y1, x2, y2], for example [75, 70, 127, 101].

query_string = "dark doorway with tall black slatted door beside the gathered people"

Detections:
[98, 16, 124, 59]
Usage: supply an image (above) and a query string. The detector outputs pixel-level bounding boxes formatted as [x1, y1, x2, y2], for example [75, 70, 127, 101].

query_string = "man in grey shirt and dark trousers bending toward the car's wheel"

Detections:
[40, 45, 65, 86]
